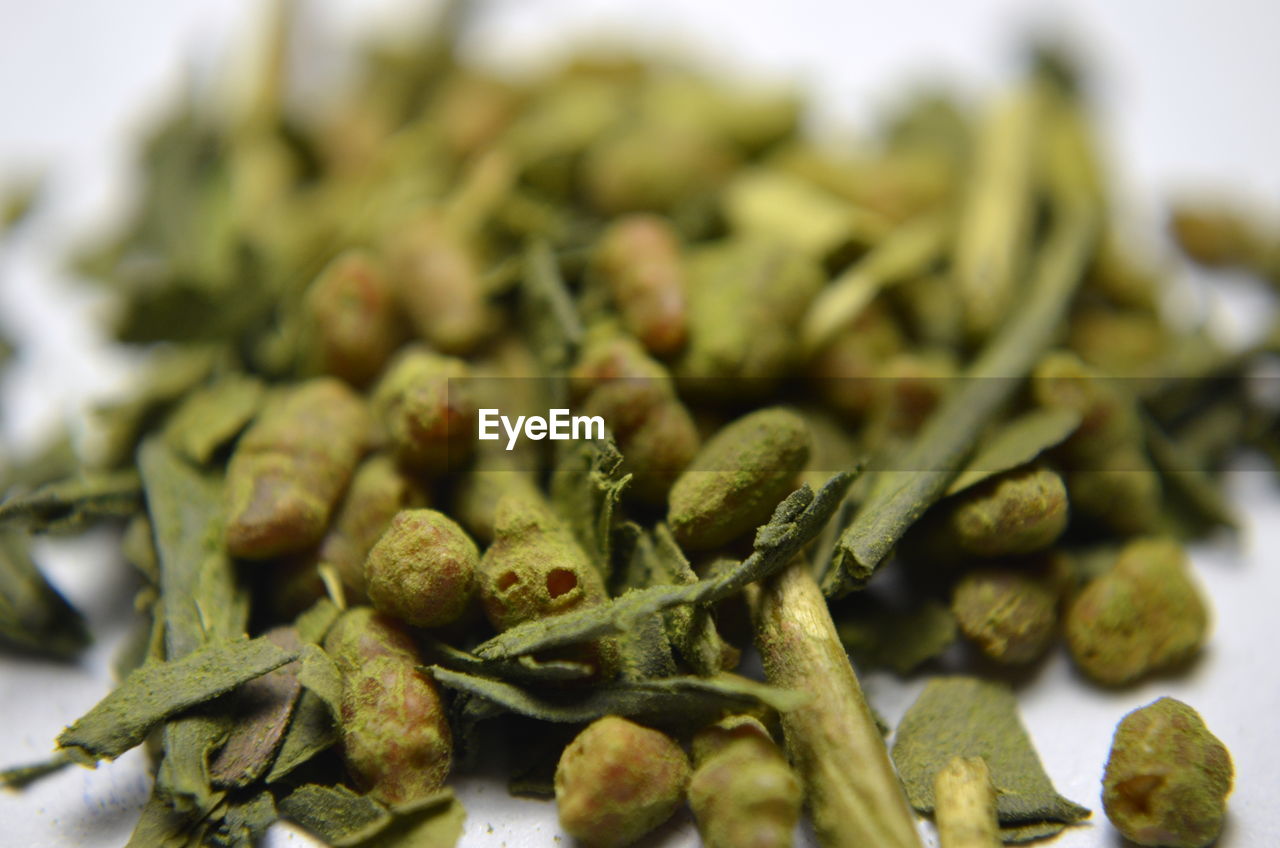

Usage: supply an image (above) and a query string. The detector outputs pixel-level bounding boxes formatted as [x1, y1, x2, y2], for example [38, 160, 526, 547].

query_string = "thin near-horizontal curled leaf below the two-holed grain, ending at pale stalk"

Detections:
[430, 666, 808, 725]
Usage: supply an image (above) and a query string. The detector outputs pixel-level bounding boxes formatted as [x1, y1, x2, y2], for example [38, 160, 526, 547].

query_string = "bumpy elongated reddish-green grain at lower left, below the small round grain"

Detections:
[325, 607, 453, 804]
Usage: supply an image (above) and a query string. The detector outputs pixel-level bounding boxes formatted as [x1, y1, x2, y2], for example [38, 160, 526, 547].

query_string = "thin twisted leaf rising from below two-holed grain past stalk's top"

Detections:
[475, 473, 852, 660]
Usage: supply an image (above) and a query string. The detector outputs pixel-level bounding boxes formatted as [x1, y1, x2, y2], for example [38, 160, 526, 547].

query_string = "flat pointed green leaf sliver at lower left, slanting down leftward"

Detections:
[58, 637, 298, 763]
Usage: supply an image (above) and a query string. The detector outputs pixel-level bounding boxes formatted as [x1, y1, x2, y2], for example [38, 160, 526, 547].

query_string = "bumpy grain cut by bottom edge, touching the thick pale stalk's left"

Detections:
[689, 716, 804, 848]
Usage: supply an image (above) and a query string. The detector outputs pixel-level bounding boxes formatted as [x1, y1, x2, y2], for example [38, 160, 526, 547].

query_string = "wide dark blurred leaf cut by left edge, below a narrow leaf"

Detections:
[0, 525, 90, 660]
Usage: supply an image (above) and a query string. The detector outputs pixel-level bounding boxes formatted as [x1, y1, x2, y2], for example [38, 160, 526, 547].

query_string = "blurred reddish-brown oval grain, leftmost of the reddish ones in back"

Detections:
[306, 250, 401, 386]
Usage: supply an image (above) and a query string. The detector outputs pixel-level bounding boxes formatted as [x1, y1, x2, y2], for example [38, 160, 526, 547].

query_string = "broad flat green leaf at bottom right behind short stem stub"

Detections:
[893, 676, 1089, 842]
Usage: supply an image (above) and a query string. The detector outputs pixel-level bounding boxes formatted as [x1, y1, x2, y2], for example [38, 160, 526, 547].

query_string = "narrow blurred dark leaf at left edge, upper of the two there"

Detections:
[0, 470, 142, 533]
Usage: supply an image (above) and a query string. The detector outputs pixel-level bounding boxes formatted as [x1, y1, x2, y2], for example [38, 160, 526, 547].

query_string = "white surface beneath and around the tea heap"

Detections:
[0, 0, 1280, 848]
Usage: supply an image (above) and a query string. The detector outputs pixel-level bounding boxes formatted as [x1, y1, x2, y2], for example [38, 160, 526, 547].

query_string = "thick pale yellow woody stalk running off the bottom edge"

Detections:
[749, 559, 920, 848]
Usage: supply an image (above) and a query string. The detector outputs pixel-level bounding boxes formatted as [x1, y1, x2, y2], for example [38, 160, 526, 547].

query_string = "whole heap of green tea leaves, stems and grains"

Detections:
[0, 4, 1280, 848]
